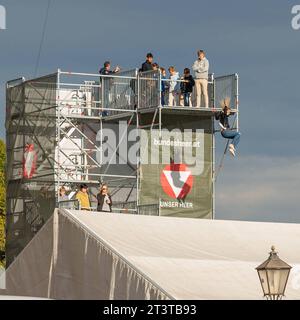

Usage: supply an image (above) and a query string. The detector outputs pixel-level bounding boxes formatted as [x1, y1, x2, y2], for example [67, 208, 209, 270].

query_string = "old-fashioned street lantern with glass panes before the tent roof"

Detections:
[256, 246, 292, 300]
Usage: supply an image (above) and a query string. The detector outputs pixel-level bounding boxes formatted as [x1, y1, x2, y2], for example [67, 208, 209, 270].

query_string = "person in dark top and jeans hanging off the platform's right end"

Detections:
[215, 97, 241, 157]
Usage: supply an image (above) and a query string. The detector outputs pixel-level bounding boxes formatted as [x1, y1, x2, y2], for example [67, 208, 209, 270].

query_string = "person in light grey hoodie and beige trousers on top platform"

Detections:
[192, 50, 209, 108]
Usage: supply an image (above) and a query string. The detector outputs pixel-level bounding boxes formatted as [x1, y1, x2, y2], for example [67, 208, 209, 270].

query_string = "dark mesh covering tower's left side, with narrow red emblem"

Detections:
[6, 74, 57, 264]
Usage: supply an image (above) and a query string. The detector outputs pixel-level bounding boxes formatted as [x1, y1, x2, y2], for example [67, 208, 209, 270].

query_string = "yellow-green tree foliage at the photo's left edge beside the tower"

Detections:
[0, 140, 6, 266]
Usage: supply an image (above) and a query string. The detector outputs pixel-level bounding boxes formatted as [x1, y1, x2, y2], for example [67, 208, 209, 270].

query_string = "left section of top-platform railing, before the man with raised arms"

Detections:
[57, 69, 137, 118]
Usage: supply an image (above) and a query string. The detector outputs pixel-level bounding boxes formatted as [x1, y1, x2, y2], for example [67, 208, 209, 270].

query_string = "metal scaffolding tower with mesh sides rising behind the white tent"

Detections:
[6, 69, 239, 264]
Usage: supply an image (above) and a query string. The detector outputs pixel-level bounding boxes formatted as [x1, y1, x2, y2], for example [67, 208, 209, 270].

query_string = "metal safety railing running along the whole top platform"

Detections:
[59, 69, 238, 117]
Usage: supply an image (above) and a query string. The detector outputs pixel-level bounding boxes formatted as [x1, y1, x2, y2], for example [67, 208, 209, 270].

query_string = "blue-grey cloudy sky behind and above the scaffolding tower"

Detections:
[0, 0, 300, 223]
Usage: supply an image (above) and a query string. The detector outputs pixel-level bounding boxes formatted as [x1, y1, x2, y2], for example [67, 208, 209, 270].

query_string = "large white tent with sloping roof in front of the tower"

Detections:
[0, 209, 300, 299]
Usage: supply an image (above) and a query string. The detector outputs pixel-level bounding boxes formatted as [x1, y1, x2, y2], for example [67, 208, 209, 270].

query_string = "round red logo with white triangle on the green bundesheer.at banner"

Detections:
[160, 163, 194, 200]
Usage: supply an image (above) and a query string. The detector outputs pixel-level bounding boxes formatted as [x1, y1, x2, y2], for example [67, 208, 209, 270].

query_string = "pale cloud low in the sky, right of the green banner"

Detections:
[217, 156, 300, 222]
